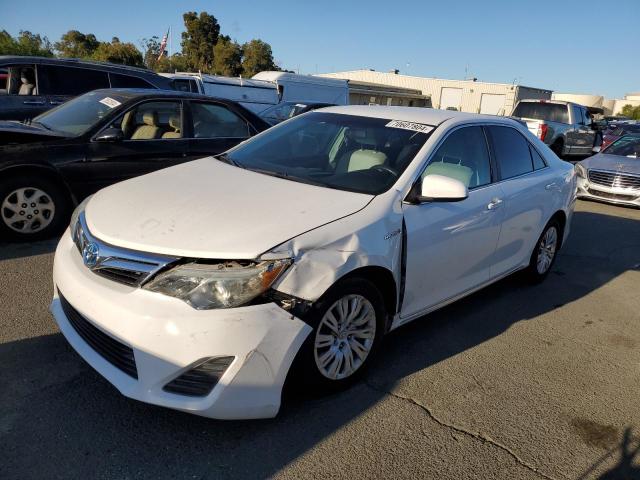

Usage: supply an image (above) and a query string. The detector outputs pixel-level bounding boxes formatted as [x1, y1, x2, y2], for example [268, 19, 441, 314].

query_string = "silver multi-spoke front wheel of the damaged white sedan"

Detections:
[314, 295, 376, 380]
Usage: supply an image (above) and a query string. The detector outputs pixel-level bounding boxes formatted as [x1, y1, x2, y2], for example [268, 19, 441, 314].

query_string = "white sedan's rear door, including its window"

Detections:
[487, 125, 560, 278]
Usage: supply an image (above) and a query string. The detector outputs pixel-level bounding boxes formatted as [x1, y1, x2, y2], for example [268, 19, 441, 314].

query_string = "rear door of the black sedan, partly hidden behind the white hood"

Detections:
[188, 100, 253, 159]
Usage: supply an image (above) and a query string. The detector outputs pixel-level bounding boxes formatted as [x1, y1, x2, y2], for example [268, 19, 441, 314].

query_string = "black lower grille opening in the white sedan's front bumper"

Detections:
[58, 292, 138, 379]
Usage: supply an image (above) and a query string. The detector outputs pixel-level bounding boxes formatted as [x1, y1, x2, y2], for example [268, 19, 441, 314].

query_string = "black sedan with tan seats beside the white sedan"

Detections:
[0, 89, 269, 240]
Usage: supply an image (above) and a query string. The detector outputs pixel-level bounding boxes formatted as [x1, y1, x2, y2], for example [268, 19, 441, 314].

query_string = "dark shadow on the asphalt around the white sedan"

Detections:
[0, 207, 640, 479]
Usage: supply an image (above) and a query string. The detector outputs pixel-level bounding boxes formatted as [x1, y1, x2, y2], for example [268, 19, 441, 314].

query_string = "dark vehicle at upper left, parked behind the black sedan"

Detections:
[0, 56, 172, 121]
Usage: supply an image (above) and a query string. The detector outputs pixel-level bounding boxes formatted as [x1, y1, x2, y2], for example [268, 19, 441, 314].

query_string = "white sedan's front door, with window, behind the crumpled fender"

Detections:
[401, 126, 503, 319]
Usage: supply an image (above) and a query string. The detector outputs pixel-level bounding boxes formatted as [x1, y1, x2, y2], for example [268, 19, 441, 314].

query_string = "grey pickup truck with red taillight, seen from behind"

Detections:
[511, 100, 598, 157]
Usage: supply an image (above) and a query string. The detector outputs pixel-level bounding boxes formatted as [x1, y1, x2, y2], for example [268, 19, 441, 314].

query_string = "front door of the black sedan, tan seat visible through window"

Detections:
[74, 100, 189, 194]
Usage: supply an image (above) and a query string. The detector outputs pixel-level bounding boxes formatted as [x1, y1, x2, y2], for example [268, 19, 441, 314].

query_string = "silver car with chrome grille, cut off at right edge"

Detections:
[576, 134, 640, 207]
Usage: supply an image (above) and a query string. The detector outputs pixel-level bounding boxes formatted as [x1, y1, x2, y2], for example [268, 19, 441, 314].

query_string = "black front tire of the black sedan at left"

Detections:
[0, 174, 72, 242]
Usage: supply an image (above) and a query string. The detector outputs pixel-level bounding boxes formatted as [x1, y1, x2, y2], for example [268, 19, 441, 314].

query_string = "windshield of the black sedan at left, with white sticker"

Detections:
[32, 92, 125, 136]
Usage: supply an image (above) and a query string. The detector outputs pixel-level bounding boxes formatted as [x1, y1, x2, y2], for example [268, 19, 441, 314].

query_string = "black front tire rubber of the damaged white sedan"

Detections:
[287, 277, 387, 393]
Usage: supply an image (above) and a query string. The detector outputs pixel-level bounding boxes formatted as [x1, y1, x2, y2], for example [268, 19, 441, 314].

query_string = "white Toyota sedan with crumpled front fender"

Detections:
[51, 106, 576, 419]
